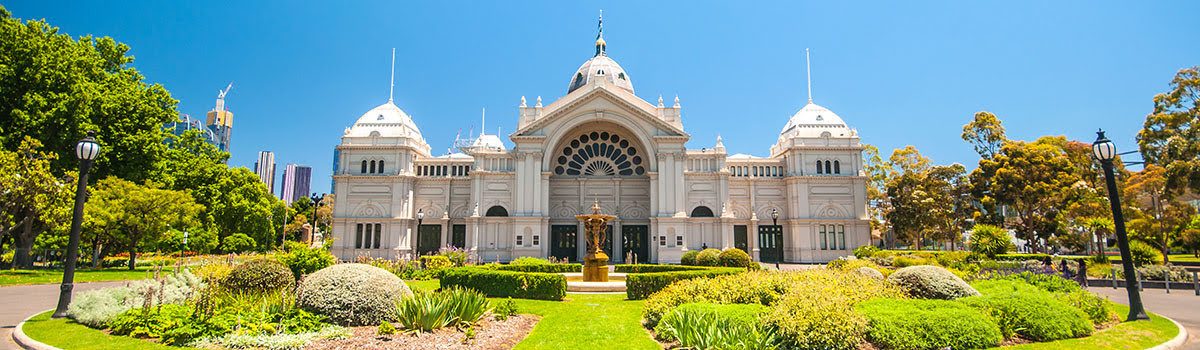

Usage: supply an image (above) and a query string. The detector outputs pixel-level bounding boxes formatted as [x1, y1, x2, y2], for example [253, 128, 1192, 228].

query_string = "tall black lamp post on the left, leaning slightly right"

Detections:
[54, 131, 100, 318]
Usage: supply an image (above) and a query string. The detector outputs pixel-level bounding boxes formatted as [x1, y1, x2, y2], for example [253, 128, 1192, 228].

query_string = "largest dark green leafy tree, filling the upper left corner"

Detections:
[0, 8, 178, 181]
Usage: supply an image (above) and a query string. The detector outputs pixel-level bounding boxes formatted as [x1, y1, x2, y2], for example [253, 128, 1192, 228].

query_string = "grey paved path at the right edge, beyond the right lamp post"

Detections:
[1087, 286, 1200, 350]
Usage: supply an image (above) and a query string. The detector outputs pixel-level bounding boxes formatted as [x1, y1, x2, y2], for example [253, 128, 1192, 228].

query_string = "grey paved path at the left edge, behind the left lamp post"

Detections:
[0, 280, 125, 349]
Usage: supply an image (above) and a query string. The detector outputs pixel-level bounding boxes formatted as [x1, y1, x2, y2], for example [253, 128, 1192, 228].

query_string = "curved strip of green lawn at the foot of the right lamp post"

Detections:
[992, 304, 1180, 350]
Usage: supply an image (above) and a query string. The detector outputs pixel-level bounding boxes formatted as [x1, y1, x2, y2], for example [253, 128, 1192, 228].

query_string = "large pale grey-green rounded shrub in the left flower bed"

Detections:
[296, 264, 413, 326]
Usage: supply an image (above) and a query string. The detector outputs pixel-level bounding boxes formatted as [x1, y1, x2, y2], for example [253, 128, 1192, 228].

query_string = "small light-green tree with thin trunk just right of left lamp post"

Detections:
[86, 176, 204, 270]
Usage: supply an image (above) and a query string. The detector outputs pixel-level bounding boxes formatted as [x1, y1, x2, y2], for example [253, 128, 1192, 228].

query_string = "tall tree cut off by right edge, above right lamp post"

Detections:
[1138, 66, 1200, 194]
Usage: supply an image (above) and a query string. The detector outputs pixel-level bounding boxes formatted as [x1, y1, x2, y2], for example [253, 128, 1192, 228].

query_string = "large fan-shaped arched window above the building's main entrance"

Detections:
[554, 132, 646, 176]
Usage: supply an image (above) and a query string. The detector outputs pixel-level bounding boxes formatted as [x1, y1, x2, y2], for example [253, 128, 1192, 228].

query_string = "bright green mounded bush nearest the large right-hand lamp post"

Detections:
[959, 279, 1093, 342]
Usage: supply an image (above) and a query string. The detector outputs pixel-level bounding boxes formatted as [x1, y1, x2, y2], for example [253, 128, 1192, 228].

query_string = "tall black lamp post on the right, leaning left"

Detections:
[1092, 129, 1150, 321]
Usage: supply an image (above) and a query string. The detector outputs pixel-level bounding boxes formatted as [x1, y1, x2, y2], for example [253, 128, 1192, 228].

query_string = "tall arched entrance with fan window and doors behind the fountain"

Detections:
[545, 122, 652, 263]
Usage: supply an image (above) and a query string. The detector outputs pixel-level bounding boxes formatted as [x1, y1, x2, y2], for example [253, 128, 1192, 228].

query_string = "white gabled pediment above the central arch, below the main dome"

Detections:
[512, 84, 688, 137]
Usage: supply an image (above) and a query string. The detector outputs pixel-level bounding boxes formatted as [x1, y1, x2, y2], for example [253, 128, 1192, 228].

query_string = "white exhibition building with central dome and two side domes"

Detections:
[332, 23, 870, 264]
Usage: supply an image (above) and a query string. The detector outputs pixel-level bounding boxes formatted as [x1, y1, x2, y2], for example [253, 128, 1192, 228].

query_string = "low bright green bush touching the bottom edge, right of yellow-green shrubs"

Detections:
[856, 298, 1004, 350]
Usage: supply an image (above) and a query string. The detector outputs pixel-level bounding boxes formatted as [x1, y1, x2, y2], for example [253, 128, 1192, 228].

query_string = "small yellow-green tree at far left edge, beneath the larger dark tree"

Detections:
[0, 137, 77, 268]
